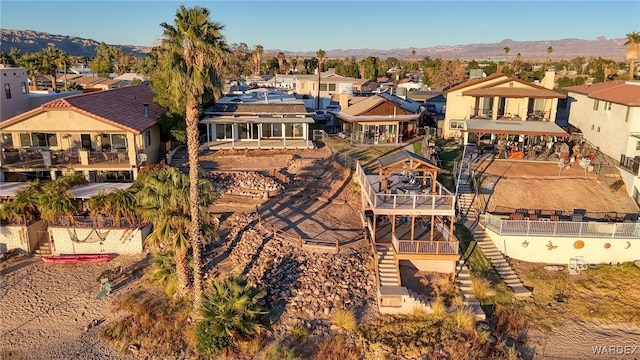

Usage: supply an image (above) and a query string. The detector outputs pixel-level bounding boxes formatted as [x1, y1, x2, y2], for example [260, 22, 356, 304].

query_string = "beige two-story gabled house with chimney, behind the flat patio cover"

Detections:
[442, 72, 566, 138]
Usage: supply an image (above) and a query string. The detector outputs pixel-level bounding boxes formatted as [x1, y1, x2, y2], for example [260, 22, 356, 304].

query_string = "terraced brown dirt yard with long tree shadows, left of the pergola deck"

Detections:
[204, 147, 362, 244]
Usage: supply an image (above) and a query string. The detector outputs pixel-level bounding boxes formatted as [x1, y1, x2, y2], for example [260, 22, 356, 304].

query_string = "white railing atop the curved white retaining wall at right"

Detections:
[484, 214, 640, 238]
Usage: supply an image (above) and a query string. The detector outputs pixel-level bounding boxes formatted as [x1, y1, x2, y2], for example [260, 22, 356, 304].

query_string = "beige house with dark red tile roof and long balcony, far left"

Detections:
[0, 85, 165, 182]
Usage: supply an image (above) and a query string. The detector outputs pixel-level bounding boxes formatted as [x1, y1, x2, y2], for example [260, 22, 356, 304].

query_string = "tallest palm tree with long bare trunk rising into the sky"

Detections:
[161, 5, 229, 308]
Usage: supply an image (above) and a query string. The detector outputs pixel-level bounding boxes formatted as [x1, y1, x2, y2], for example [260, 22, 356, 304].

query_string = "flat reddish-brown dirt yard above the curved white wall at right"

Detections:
[475, 160, 638, 213]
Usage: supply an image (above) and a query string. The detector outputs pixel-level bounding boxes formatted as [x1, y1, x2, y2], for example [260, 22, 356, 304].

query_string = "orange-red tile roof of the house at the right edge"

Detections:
[565, 80, 640, 106]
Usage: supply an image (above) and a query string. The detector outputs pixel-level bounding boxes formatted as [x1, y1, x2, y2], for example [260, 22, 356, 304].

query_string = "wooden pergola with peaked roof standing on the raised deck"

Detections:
[378, 150, 440, 193]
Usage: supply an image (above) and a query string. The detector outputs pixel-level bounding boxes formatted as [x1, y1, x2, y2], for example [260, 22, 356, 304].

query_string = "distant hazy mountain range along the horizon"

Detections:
[0, 29, 626, 61]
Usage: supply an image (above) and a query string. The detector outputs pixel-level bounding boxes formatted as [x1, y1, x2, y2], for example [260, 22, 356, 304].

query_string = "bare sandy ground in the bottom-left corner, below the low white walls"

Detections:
[0, 256, 142, 360]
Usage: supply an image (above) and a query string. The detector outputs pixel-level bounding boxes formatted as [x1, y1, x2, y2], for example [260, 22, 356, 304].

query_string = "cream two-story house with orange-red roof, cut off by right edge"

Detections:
[566, 80, 640, 202]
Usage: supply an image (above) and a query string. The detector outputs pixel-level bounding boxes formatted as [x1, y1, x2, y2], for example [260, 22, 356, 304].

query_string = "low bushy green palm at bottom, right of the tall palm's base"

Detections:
[196, 276, 267, 355]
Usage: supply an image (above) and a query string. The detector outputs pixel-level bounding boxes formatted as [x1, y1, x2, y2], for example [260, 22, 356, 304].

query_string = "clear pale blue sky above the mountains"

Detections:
[0, 0, 640, 51]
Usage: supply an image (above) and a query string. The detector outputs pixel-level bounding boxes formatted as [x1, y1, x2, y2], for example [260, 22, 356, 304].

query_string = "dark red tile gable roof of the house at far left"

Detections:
[0, 85, 166, 134]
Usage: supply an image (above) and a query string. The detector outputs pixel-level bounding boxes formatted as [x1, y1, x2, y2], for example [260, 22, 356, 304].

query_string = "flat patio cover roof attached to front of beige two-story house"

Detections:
[461, 119, 569, 137]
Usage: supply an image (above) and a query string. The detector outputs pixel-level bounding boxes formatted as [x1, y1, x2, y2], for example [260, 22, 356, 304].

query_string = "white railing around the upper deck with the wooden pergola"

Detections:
[356, 162, 455, 211]
